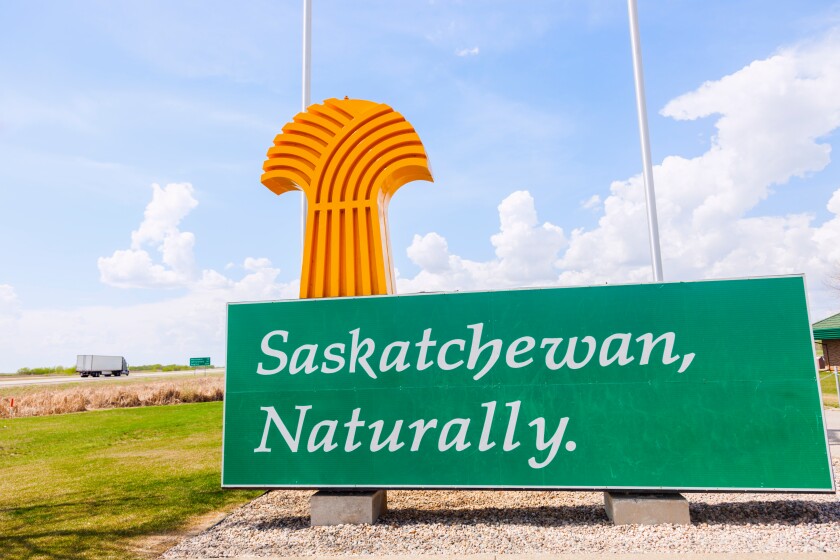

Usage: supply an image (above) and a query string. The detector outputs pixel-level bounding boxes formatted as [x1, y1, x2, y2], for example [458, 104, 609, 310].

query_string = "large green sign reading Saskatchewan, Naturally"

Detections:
[222, 276, 833, 491]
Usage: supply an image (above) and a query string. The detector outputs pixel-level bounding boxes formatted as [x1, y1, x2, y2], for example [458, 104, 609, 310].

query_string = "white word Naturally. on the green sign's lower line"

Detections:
[254, 401, 577, 469]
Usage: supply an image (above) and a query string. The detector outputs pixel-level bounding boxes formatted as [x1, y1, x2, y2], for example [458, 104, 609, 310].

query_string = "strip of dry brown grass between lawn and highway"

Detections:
[0, 377, 224, 418]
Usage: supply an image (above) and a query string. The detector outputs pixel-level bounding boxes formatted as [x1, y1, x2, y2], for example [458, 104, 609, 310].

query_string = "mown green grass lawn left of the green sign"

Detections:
[0, 402, 259, 559]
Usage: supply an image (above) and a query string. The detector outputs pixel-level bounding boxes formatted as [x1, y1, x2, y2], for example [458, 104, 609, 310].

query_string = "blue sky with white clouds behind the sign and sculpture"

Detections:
[0, 0, 840, 371]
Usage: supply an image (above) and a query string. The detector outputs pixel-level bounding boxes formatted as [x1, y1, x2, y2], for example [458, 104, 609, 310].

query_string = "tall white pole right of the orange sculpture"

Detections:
[627, 0, 662, 282]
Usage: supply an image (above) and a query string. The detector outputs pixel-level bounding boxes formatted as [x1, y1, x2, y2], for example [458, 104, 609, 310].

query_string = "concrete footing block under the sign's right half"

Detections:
[604, 492, 691, 525]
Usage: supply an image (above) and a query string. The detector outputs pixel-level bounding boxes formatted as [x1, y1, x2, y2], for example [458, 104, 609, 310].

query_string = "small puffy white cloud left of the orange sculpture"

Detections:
[97, 183, 198, 288]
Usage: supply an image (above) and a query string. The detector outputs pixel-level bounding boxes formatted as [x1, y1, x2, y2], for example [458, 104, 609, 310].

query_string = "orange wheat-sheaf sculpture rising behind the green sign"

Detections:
[261, 99, 433, 298]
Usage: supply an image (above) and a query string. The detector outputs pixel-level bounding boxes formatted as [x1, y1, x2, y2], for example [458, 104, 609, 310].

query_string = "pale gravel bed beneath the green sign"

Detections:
[162, 460, 840, 558]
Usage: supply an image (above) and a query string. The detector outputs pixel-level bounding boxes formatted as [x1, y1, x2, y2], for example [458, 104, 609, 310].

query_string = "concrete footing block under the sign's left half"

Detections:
[309, 490, 388, 527]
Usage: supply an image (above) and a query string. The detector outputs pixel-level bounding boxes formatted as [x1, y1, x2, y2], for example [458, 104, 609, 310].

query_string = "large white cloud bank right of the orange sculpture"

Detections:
[399, 32, 840, 317]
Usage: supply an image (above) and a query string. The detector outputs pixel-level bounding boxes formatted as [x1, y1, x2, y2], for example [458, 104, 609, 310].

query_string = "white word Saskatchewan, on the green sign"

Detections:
[257, 323, 694, 380]
